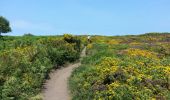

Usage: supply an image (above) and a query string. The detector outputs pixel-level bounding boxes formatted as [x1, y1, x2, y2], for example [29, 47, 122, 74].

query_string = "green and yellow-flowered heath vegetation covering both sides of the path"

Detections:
[0, 33, 170, 100]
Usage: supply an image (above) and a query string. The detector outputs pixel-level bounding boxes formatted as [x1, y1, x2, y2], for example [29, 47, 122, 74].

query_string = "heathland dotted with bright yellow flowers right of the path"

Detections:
[69, 33, 170, 100]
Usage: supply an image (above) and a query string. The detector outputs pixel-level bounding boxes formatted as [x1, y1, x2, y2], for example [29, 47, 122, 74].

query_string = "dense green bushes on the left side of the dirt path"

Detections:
[0, 36, 81, 100]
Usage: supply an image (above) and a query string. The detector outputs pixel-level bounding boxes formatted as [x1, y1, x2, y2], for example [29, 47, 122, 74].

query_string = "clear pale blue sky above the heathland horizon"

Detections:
[0, 0, 170, 35]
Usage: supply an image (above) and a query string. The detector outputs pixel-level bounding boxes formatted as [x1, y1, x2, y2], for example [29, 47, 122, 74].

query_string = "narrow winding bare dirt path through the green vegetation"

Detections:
[43, 48, 86, 100]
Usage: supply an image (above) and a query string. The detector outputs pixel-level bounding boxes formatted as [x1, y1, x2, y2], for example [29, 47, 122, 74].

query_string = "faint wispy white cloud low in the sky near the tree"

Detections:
[11, 20, 55, 31]
